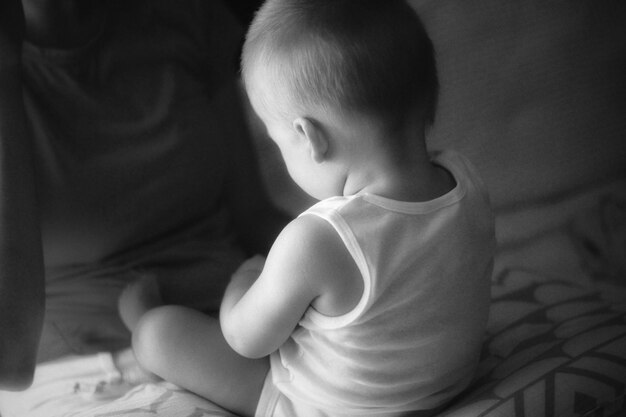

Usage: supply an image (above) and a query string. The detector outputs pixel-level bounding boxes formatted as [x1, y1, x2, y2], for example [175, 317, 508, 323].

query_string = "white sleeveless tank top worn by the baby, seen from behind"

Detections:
[271, 152, 495, 416]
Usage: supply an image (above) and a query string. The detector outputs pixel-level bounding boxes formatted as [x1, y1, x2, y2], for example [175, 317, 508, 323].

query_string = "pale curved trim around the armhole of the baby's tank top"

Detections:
[301, 208, 372, 329]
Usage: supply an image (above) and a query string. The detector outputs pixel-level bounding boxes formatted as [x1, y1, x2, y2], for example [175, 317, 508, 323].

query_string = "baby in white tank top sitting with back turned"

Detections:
[122, 0, 495, 417]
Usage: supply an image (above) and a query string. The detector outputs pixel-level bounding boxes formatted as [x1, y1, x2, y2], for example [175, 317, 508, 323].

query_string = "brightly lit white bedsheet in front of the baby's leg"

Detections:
[0, 353, 234, 417]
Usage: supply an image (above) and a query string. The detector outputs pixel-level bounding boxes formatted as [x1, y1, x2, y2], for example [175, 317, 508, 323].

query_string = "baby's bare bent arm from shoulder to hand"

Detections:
[220, 216, 363, 358]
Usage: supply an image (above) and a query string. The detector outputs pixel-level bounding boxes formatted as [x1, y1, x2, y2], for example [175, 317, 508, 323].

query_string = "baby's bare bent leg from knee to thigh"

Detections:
[133, 306, 269, 416]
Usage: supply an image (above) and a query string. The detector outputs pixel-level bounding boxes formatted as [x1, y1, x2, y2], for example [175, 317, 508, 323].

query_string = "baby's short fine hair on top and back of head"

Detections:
[242, 0, 439, 128]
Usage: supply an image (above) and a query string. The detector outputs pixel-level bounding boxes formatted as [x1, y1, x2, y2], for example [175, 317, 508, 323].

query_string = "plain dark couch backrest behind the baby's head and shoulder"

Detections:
[410, 0, 626, 210]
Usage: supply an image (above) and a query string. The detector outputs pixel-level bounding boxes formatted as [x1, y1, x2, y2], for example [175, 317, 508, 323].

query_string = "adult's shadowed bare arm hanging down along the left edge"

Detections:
[0, 0, 45, 390]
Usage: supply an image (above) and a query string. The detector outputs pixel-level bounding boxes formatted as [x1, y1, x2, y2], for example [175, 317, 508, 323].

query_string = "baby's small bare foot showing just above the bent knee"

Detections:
[118, 275, 163, 331]
